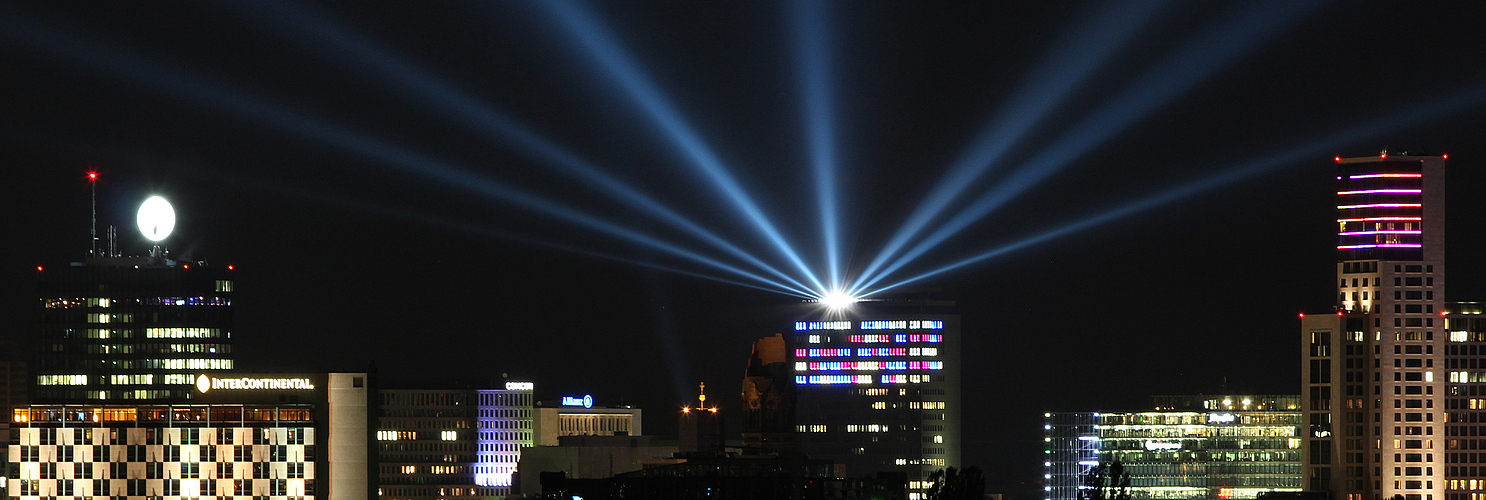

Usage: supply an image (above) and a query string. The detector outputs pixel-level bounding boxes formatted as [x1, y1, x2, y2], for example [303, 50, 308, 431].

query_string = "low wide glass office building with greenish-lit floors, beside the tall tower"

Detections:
[1043, 396, 1302, 500]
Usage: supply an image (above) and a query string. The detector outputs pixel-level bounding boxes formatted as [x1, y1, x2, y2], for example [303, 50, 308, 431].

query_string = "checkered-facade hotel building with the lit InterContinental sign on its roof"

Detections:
[7, 374, 376, 500]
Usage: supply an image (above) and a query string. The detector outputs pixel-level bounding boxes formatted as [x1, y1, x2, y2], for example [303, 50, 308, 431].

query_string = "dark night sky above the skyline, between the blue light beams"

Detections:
[0, 1, 1486, 491]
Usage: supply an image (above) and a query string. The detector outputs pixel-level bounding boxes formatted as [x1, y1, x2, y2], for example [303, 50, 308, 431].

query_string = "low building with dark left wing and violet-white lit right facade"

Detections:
[376, 382, 532, 500]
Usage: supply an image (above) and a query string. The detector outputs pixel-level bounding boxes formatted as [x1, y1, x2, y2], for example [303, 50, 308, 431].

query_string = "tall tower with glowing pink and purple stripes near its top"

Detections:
[1300, 153, 1444, 500]
